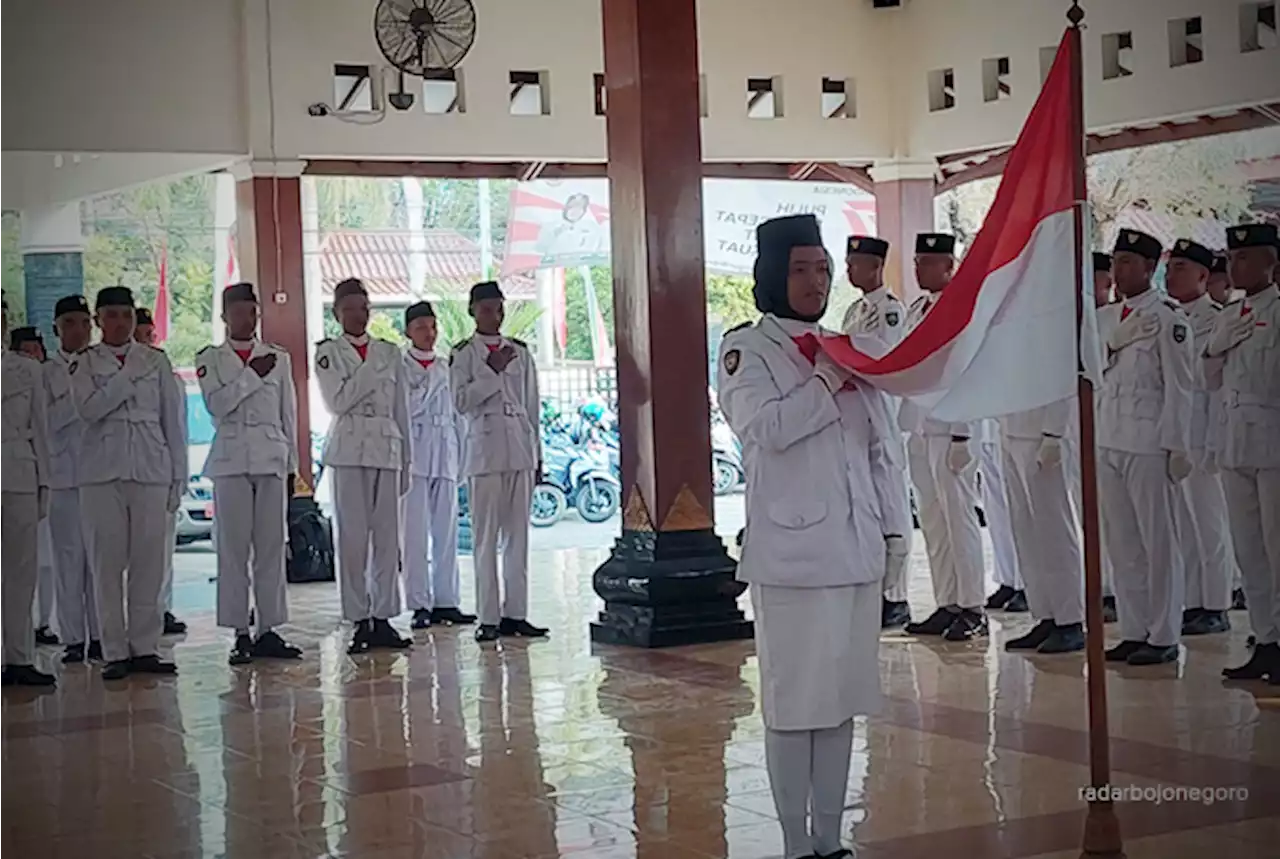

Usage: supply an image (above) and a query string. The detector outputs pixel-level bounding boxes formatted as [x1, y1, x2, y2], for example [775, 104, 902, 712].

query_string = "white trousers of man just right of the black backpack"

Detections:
[330, 465, 401, 621]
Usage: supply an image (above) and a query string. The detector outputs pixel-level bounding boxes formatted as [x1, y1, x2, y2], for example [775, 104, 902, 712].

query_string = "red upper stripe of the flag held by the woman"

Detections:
[823, 38, 1083, 376]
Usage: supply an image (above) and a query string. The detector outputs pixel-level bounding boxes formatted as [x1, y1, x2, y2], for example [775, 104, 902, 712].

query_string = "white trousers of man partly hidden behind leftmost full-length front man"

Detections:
[49, 489, 101, 644]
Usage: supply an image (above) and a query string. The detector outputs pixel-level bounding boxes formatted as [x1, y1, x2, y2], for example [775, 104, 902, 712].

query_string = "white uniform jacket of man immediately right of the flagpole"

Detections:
[1098, 289, 1196, 454]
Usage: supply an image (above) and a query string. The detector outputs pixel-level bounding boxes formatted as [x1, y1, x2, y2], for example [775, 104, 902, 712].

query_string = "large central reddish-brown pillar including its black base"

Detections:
[591, 0, 751, 646]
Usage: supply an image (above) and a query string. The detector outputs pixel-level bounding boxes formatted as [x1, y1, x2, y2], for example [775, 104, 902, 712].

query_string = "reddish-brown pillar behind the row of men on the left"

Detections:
[236, 161, 312, 486]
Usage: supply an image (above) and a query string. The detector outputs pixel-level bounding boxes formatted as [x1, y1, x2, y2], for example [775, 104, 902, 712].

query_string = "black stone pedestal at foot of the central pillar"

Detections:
[591, 529, 753, 648]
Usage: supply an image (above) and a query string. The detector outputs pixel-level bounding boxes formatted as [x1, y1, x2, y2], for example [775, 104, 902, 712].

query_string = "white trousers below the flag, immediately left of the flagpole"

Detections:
[1003, 439, 1084, 626]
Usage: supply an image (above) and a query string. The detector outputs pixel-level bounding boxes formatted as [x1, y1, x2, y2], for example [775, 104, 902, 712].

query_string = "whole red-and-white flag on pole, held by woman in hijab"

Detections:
[822, 31, 1102, 421]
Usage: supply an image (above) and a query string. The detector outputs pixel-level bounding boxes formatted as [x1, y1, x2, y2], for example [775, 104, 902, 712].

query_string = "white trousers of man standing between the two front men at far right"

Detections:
[1176, 466, 1233, 612]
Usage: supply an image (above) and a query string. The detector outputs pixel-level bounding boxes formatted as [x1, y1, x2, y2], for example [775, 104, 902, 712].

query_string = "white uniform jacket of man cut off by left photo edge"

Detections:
[0, 348, 49, 494]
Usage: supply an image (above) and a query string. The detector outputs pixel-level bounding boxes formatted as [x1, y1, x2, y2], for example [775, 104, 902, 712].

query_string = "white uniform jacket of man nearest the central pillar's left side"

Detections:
[449, 335, 543, 478]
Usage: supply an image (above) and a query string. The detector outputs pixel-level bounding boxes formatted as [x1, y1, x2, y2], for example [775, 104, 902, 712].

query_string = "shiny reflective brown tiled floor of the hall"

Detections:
[0, 550, 1280, 859]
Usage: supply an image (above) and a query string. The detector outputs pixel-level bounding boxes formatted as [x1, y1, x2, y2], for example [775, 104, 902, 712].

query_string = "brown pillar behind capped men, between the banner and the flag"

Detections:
[870, 161, 937, 303]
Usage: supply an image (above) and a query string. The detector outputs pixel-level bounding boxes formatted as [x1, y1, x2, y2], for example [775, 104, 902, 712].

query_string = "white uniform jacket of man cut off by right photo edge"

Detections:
[1204, 284, 1280, 469]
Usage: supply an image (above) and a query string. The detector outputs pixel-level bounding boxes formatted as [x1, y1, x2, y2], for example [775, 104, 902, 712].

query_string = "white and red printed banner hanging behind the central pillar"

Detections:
[502, 179, 876, 275]
